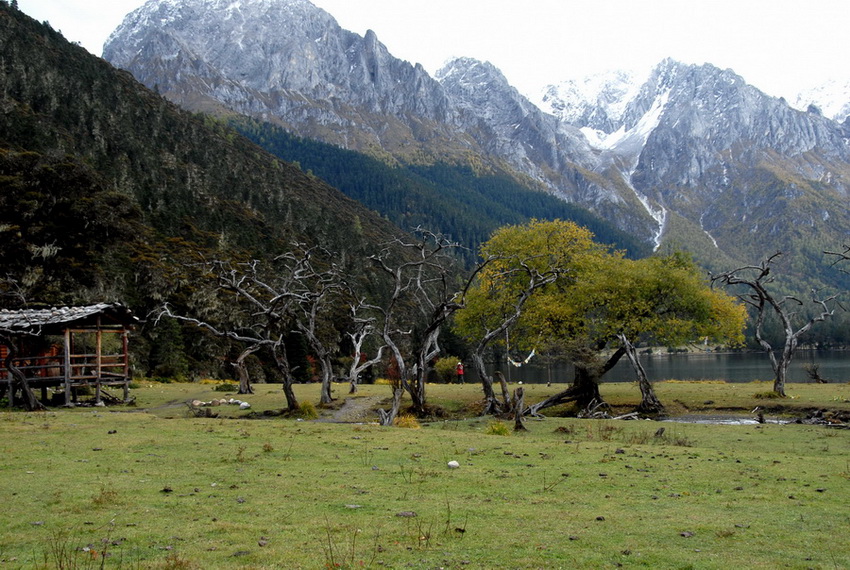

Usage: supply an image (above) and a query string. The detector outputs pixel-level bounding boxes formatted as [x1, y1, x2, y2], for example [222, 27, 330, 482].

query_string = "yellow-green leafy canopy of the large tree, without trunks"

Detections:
[457, 221, 746, 351]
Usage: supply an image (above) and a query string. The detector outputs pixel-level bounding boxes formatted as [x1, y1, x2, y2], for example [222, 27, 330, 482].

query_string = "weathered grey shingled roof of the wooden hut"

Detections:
[0, 303, 139, 334]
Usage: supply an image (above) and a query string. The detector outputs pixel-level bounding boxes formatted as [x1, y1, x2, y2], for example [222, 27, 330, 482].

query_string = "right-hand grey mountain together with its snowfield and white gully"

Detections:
[541, 60, 850, 255]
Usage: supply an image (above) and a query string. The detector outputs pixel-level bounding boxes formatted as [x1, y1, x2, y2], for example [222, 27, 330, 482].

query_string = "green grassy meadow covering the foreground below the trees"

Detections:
[0, 382, 850, 569]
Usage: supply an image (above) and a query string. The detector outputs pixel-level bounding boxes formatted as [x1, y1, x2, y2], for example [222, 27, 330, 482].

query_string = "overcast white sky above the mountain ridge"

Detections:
[18, 0, 850, 99]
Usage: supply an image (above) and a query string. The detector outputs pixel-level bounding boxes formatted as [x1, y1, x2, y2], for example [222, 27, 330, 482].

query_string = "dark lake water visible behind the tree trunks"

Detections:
[484, 350, 850, 383]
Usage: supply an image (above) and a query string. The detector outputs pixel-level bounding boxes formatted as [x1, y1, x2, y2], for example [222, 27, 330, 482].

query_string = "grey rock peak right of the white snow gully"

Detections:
[622, 60, 850, 255]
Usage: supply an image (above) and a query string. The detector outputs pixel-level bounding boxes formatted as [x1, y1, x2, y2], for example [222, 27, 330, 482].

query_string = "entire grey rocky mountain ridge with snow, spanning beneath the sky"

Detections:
[104, 0, 850, 284]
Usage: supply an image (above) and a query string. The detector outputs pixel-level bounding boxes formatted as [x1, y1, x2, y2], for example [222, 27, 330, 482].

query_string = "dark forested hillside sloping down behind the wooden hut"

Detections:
[0, 3, 398, 378]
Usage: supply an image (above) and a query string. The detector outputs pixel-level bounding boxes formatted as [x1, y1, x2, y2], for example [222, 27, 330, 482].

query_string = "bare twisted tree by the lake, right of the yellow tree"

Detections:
[711, 252, 838, 397]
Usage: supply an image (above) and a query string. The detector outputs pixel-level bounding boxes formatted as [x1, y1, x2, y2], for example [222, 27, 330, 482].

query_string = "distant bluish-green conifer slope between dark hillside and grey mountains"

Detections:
[228, 116, 651, 257]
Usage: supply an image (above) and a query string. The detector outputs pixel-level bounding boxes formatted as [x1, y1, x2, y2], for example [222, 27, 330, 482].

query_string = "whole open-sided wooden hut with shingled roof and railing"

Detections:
[0, 303, 138, 406]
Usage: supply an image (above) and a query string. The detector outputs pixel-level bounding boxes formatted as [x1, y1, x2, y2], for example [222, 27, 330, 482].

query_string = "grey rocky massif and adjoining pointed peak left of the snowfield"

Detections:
[104, 0, 651, 235]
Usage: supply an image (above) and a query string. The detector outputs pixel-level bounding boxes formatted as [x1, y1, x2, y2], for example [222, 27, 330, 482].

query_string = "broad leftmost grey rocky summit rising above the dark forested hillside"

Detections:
[103, 0, 450, 148]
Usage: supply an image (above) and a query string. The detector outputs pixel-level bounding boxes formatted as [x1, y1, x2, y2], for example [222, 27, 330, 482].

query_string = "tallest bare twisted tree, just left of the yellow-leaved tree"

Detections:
[371, 228, 485, 416]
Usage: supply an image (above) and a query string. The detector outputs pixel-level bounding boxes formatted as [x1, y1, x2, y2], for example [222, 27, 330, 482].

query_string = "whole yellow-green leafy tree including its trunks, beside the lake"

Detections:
[456, 221, 746, 413]
